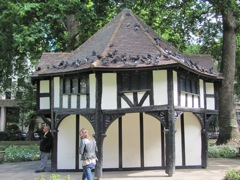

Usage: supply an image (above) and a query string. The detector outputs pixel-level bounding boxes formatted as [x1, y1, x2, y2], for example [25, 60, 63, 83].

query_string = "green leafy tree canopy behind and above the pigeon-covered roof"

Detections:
[0, 0, 240, 144]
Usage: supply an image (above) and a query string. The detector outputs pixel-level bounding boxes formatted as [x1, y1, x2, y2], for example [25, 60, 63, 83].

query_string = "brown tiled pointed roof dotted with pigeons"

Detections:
[34, 9, 222, 78]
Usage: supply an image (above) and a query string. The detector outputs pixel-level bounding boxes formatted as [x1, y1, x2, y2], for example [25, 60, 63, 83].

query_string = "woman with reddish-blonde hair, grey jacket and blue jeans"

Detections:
[79, 128, 97, 180]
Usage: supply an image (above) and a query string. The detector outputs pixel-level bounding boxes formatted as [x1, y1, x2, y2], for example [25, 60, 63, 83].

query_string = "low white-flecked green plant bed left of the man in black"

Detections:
[4, 144, 40, 162]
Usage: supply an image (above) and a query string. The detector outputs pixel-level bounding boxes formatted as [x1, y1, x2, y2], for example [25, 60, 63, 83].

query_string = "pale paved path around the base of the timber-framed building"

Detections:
[0, 158, 240, 180]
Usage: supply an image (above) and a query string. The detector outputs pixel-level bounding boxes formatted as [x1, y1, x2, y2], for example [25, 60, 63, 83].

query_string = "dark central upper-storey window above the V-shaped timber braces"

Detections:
[120, 72, 152, 91]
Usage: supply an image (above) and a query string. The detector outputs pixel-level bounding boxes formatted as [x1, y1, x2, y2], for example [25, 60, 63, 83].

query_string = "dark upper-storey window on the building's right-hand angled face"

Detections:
[179, 75, 199, 94]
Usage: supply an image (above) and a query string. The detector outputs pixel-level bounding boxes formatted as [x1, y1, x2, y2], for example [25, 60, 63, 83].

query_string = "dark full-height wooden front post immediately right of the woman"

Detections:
[95, 72, 103, 179]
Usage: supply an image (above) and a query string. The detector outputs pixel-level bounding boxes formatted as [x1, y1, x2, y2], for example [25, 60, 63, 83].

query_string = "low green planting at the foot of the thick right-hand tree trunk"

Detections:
[208, 146, 238, 158]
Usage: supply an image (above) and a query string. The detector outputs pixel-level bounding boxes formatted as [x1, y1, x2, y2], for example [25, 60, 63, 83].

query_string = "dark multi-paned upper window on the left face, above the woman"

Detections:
[63, 75, 88, 94]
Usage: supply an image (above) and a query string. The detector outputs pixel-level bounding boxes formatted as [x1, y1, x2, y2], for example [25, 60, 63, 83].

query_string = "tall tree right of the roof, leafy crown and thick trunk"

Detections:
[118, 0, 240, 145]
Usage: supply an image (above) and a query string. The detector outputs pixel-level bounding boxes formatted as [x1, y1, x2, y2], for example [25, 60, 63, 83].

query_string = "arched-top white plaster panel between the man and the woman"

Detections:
[57, 115, 77, 169]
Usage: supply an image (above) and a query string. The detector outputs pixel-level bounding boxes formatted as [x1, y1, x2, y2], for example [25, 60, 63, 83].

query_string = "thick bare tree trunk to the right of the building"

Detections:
[216, 9, 239, 145]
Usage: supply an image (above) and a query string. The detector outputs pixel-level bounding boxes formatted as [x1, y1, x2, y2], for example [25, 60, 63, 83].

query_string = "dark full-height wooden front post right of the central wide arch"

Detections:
[165, 70, 175, 177]
